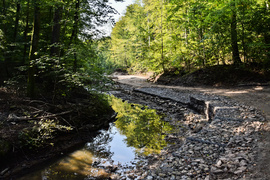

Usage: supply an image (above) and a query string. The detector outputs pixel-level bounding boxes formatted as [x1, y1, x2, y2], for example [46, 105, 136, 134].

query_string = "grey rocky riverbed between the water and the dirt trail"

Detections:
[107, 84, 266, 180]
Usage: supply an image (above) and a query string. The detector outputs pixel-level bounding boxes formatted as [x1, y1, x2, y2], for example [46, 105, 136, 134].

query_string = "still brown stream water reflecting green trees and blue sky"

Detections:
[20, 98, 172, 180]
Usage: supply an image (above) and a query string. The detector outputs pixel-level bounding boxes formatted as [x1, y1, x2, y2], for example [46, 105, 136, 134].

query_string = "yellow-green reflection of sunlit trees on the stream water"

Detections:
[112, 98, 171, 154]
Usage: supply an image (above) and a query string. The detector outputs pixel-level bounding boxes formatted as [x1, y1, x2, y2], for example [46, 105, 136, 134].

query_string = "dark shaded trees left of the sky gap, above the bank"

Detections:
[0, 0, 122, 97]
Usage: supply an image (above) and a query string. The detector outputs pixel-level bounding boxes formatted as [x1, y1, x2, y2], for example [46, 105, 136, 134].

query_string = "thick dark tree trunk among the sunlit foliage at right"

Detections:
[231, 3, 241, 65]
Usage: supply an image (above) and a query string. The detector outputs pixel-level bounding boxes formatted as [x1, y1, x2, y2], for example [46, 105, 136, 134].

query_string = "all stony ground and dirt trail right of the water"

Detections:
[110, 76, 270, 179]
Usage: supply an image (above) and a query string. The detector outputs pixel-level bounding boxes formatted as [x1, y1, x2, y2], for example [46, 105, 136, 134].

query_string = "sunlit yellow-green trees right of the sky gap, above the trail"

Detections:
[108, 0, 270, 72]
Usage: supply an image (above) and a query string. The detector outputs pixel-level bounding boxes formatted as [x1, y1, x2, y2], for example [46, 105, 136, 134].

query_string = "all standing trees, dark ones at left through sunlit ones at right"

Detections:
[0, 0, 270, 90]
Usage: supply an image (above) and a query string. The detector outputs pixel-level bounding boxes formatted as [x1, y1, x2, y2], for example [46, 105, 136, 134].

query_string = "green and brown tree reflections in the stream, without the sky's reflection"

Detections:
[23, 97, 172, 179]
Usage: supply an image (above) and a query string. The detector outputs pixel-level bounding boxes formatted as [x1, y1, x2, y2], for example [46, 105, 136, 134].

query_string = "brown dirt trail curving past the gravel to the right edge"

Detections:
[115, 75, 270, 179]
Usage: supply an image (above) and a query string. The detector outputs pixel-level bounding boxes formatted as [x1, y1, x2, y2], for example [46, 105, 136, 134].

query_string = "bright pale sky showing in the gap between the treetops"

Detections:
[102, 0, 135, 36]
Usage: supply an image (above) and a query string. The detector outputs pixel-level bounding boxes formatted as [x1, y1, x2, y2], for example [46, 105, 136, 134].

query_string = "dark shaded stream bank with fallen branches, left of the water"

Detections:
[0, 87, 115, 179]
